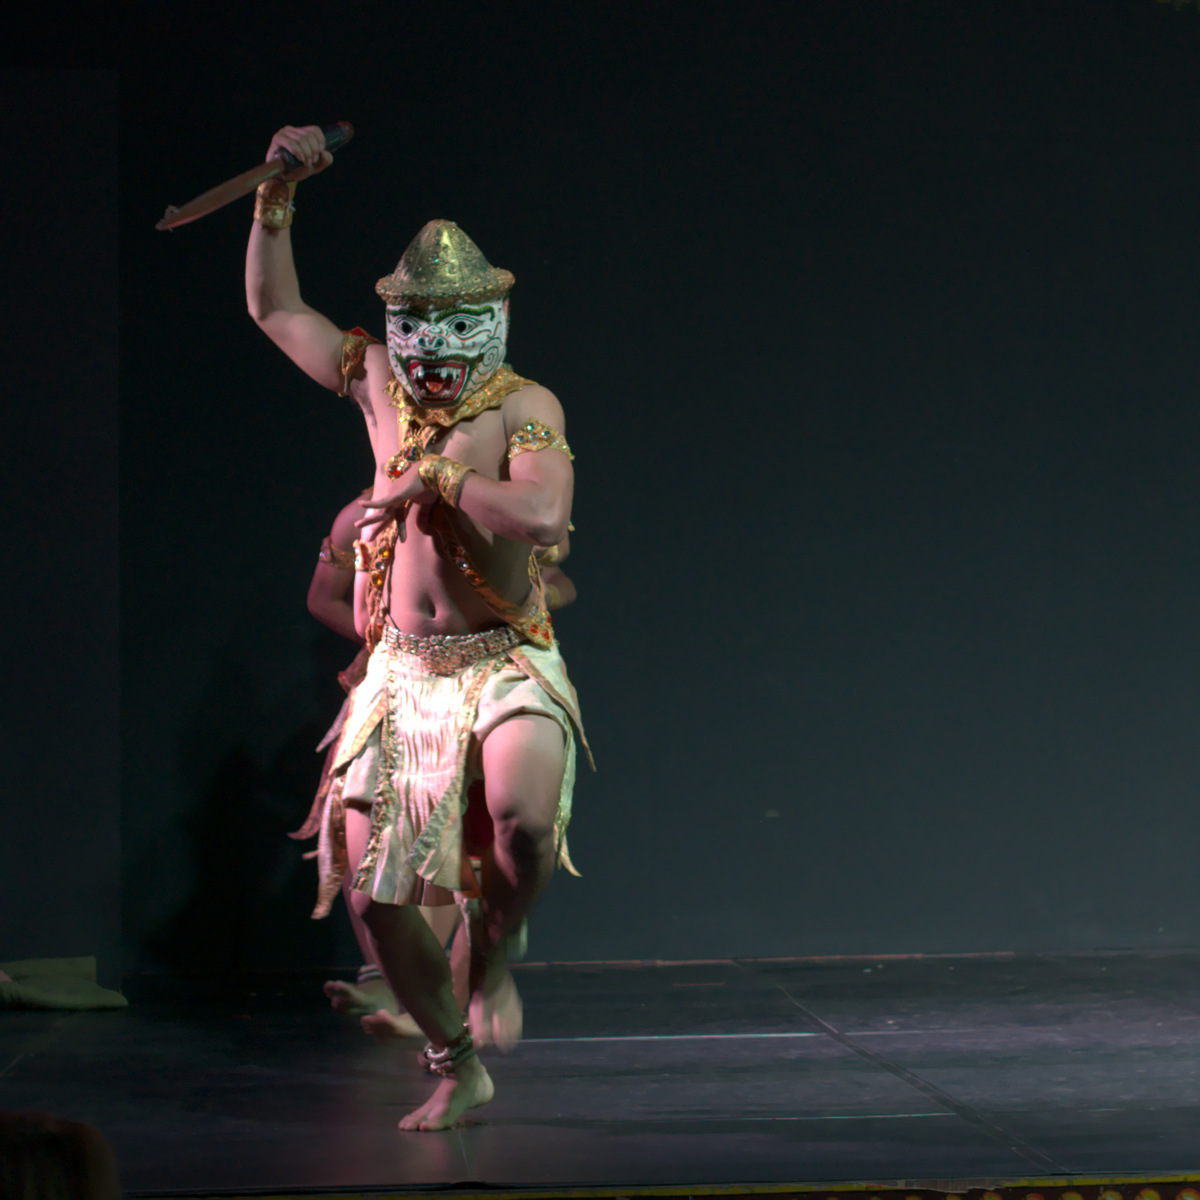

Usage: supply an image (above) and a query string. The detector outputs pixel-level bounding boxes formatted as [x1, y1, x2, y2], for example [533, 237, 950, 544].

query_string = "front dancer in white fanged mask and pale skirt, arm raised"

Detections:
[246, 126, 587, 1129]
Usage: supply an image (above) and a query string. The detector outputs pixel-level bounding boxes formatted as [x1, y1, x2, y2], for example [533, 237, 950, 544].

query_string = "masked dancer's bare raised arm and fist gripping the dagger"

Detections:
[246, 125, 343, 391]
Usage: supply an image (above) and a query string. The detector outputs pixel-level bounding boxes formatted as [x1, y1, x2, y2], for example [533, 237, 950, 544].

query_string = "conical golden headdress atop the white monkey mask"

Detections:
[376, 221, 512, 307]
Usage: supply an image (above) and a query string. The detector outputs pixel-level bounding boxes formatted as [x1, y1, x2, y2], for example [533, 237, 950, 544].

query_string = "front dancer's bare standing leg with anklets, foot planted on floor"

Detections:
[346, 808, 494, 1130]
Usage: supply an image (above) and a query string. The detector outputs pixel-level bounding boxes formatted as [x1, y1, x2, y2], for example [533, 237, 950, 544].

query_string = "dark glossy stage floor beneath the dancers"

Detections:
[0, 953, 1200, 1195]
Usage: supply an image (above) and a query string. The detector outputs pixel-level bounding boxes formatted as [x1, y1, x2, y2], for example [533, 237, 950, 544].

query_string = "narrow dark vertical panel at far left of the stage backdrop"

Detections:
[0, 68, 121, 986]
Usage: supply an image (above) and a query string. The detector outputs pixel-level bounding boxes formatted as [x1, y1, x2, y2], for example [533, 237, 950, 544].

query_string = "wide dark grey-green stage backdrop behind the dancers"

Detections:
[121, 0, 1200, 968]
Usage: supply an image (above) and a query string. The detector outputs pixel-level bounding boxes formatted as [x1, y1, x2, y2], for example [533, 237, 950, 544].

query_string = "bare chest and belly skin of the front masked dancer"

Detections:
[365, 346, 532, 637]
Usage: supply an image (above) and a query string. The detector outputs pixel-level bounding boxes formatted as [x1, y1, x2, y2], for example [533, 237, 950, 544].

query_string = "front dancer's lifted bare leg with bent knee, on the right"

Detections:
[469, 713, 566, 1050]
